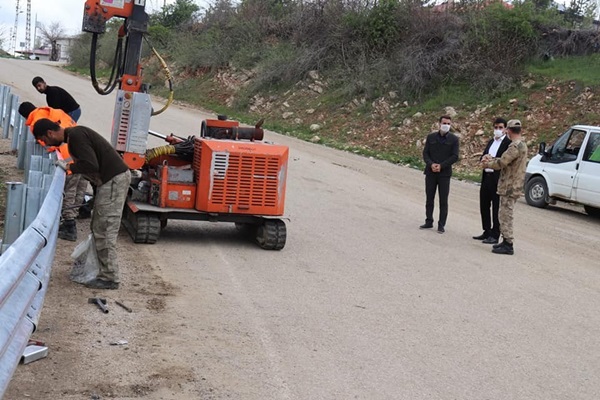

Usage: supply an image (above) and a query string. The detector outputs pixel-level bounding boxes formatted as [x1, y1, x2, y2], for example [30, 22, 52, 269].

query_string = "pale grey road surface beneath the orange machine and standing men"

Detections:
[0, 60, 600, 400]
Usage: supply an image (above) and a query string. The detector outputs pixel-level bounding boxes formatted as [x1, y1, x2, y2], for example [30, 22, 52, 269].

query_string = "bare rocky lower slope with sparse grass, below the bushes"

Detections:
[117, 54, 600, 179]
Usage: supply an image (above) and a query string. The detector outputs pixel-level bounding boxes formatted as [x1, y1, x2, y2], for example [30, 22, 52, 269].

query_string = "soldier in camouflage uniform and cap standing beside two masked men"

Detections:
[481, 119, 527, 254]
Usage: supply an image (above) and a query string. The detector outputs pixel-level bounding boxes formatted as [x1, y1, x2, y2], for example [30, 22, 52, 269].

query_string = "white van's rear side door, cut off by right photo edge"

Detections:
[573, 132, 600, 207]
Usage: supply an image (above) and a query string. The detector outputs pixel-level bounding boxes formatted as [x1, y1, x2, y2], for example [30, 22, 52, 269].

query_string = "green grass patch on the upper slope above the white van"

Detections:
[527, 54, 600, 86]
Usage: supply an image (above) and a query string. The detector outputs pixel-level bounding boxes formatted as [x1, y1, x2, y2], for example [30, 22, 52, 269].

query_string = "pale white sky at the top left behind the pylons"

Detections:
[0, 0, 203, 50]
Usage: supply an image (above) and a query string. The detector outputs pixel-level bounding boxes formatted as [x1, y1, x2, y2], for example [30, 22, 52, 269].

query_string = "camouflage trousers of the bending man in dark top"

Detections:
[91, 171, 131, 282]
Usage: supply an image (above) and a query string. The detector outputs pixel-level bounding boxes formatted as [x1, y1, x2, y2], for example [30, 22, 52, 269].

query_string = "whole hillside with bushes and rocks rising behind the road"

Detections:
[62, 0, 600, 181]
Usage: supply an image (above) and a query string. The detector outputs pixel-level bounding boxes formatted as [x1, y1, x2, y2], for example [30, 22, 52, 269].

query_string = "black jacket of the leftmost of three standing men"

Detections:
[423, 131, 459, 176]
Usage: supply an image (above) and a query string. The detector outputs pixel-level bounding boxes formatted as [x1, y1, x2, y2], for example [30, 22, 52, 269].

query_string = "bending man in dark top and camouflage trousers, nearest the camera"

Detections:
[33, 119, 131, 289]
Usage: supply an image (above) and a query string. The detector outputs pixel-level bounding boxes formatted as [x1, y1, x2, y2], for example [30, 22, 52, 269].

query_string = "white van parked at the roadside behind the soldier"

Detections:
[524, 125, 600, 217]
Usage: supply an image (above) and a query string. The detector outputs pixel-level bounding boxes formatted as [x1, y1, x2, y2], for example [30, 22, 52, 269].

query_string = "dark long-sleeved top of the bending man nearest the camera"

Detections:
[65, 125, 129, 186]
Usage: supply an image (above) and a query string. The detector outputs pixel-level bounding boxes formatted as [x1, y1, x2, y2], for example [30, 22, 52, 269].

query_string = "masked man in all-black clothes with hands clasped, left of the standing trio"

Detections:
[419, 115, 459, 233]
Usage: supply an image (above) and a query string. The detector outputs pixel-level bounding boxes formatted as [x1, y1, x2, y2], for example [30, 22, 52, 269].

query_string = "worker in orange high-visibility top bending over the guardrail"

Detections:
[19, 101, 88, 242]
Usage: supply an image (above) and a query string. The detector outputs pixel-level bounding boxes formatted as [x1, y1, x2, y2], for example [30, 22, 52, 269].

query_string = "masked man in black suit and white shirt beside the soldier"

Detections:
[473, 118, 510, 244]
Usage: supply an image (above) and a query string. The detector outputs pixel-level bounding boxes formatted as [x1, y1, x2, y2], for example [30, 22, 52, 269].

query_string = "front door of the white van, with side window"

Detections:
[543, 128, 587, 199]
